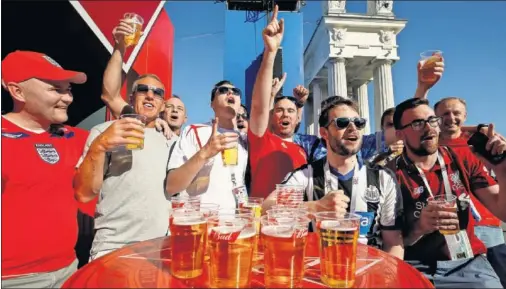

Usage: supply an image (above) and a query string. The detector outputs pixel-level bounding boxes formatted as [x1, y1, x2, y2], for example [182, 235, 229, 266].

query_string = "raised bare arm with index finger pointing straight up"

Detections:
[249, 5, 284, 137]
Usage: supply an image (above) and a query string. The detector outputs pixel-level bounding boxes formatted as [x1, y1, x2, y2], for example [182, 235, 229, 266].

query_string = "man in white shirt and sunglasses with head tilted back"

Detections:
[166, 80, 248, 208]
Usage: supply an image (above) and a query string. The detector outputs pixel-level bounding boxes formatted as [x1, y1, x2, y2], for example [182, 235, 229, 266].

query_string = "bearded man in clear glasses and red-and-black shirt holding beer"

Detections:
[393, 98, 506, 288]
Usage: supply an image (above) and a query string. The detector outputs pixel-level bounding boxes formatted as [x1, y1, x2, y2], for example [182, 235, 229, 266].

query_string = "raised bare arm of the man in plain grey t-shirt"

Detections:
[102, 20, 133, 118]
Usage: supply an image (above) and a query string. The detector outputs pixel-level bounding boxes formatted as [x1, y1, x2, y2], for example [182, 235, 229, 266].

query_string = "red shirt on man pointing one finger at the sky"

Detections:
[248, 130, 307, 198]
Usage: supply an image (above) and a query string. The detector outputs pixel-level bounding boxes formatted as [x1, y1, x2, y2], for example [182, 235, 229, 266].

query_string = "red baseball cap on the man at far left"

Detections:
[2, 50, 86, 84]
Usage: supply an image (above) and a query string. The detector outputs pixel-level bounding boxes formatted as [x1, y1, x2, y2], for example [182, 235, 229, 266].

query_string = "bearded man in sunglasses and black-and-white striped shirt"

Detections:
[264, 98, 404, 259]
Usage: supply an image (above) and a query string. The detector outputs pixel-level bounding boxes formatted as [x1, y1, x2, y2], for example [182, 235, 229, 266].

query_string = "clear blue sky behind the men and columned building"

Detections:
[166, 1, 506, 135]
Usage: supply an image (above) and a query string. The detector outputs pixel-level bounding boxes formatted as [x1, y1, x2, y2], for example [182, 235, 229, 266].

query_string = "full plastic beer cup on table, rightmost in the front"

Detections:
[314, 212, 360, 288]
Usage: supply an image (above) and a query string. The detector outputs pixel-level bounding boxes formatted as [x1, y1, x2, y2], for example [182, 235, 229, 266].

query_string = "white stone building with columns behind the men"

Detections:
[304, 0, 407, 135]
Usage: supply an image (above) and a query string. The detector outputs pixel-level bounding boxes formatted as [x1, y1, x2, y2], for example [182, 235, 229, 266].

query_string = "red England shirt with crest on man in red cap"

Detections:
[2, 117, 88, 278]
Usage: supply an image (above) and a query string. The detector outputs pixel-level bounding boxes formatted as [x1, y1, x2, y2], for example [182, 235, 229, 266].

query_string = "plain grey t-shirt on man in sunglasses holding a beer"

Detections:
[77, 121, 173, 258]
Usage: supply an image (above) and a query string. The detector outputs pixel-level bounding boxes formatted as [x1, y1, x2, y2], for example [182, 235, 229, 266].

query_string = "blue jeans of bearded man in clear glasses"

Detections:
[407, 255, 503, 289]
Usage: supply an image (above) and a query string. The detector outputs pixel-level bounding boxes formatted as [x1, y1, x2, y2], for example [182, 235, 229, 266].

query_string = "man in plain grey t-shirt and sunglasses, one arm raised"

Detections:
[74, 20, 176, 259]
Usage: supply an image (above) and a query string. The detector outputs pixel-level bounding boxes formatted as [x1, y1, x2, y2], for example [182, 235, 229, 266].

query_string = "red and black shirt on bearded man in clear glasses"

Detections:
[396, 147, 496, 263]
